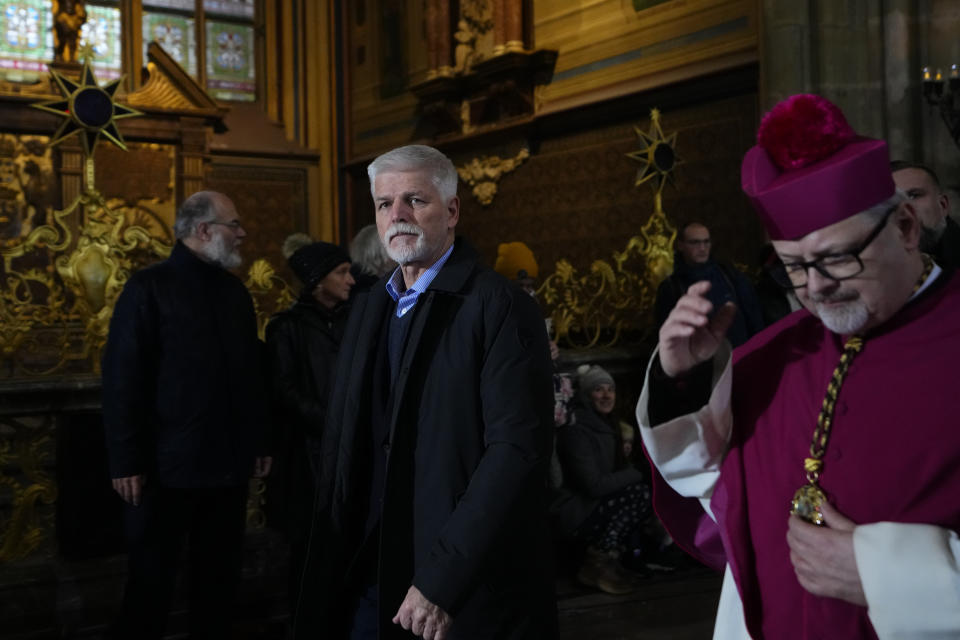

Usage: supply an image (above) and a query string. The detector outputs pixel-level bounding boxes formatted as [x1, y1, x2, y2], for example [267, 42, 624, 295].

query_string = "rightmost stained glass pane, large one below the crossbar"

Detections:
[207, 20, 257, 101]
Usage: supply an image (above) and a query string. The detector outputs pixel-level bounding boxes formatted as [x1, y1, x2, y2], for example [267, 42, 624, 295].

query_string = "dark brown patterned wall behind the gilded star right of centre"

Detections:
[455, 94, 762, 279]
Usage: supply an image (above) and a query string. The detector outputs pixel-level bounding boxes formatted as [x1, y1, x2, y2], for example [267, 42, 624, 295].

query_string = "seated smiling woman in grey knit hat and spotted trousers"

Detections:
[554, 365, 651, 594]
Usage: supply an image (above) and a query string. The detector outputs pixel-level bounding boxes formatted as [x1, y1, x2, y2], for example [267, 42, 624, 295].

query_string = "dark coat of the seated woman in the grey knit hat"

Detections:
[551, 406, 644, 536]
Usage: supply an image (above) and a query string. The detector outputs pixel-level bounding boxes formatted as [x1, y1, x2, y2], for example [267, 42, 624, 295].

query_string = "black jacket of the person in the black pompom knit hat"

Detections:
[264, 292, 349, 535]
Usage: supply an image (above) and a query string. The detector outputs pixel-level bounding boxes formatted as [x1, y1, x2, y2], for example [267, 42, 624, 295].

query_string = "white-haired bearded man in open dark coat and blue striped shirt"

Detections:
[296, 145, 556, 640]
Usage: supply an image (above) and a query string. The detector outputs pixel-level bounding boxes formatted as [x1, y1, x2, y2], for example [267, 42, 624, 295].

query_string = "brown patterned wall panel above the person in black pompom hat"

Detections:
[207, 164, 307, 282]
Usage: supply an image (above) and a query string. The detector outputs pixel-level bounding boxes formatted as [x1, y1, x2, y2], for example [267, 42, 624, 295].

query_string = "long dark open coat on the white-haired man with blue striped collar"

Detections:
[295, 238, 556, 640]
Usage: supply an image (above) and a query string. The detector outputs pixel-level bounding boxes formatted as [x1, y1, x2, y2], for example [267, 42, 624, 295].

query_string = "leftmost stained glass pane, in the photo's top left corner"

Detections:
[0, 0, 53, 82]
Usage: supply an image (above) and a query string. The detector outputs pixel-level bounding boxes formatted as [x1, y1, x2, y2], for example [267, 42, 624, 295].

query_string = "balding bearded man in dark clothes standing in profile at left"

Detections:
[103, 192, 271, 640]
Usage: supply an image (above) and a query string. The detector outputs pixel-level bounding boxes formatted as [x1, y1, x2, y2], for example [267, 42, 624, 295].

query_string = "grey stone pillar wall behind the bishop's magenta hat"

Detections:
[760, 0, 960, 205]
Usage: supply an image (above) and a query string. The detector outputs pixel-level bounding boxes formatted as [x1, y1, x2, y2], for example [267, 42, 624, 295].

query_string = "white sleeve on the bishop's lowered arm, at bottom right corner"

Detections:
[853, 522, 960, 640]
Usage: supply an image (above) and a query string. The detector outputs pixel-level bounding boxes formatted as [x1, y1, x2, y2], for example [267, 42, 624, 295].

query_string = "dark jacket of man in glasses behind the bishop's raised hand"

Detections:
[654, 254, 764, 347]
